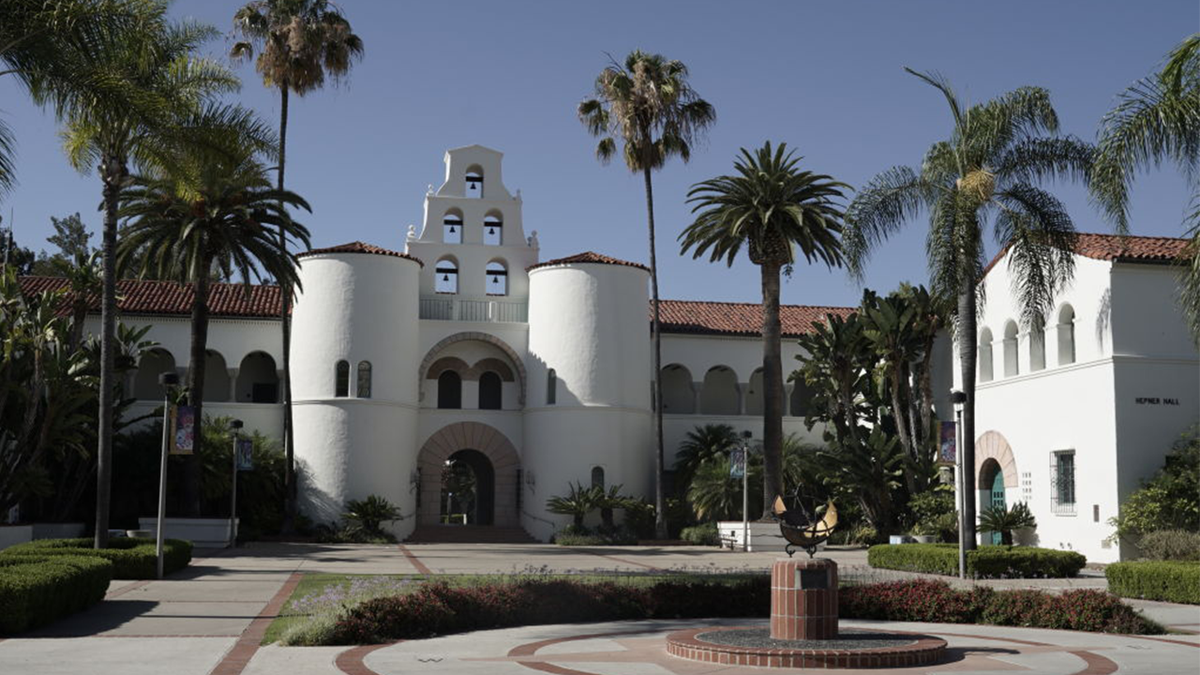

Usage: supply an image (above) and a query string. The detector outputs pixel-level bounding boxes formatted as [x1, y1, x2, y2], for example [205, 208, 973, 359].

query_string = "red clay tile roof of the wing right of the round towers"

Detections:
[659, 300, 854, 338]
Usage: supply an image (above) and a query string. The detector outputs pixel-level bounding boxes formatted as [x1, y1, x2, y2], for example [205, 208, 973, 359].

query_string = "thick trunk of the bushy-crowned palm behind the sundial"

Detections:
[758, 261, 784, 518]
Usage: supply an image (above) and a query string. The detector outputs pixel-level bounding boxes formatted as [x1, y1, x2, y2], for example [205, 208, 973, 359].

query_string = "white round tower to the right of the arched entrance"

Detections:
[524, 252, 654, 539]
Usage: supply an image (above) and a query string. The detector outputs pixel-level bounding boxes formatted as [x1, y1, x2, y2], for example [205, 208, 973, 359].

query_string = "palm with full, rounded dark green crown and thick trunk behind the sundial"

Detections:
[679, 141, 848, 516]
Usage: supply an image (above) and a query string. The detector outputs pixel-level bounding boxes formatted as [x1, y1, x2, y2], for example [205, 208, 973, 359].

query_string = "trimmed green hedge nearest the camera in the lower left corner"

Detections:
[0, 555, 113, 634]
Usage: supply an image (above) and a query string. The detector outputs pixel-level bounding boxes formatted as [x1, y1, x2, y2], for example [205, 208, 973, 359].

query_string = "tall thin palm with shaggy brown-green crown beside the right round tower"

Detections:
[577, 49, 716, 539]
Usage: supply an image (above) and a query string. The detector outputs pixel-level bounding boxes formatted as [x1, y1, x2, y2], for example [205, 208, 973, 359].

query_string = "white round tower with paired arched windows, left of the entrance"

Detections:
[292, 241, 422, 537]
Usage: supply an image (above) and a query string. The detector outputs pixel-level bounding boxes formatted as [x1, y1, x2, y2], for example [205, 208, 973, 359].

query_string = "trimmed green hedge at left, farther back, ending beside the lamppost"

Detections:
[0, 537, 192, 579]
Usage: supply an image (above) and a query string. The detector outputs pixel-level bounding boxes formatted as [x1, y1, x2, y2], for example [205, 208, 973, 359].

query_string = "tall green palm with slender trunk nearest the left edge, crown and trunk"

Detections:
[50, 1, 238, 540]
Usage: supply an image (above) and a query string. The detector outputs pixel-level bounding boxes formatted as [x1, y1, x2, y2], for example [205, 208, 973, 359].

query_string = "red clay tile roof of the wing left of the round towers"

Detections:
[20, 276, 280, 318]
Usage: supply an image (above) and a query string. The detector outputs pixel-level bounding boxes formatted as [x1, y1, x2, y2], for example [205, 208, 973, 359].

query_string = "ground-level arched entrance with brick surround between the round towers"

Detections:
[416, 422, 521, 527]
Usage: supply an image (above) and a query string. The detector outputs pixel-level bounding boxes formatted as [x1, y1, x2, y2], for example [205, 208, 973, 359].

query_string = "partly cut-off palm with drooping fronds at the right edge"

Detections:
[1092, 34, 1200, 342]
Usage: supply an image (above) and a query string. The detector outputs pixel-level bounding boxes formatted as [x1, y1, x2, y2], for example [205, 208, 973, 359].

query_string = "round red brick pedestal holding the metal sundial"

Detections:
[770, 558, 838, 640]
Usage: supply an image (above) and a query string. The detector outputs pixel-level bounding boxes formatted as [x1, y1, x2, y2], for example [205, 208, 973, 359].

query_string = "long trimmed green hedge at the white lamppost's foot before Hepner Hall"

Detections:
[866, 544, 1087, 579]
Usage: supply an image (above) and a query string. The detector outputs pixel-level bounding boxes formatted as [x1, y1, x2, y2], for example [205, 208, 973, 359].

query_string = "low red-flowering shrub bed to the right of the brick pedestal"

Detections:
[838, 580, 1147, 633]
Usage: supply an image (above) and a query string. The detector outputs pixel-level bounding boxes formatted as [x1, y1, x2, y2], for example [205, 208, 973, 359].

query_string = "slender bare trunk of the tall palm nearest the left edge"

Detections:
[94, 155, 127, 549]
